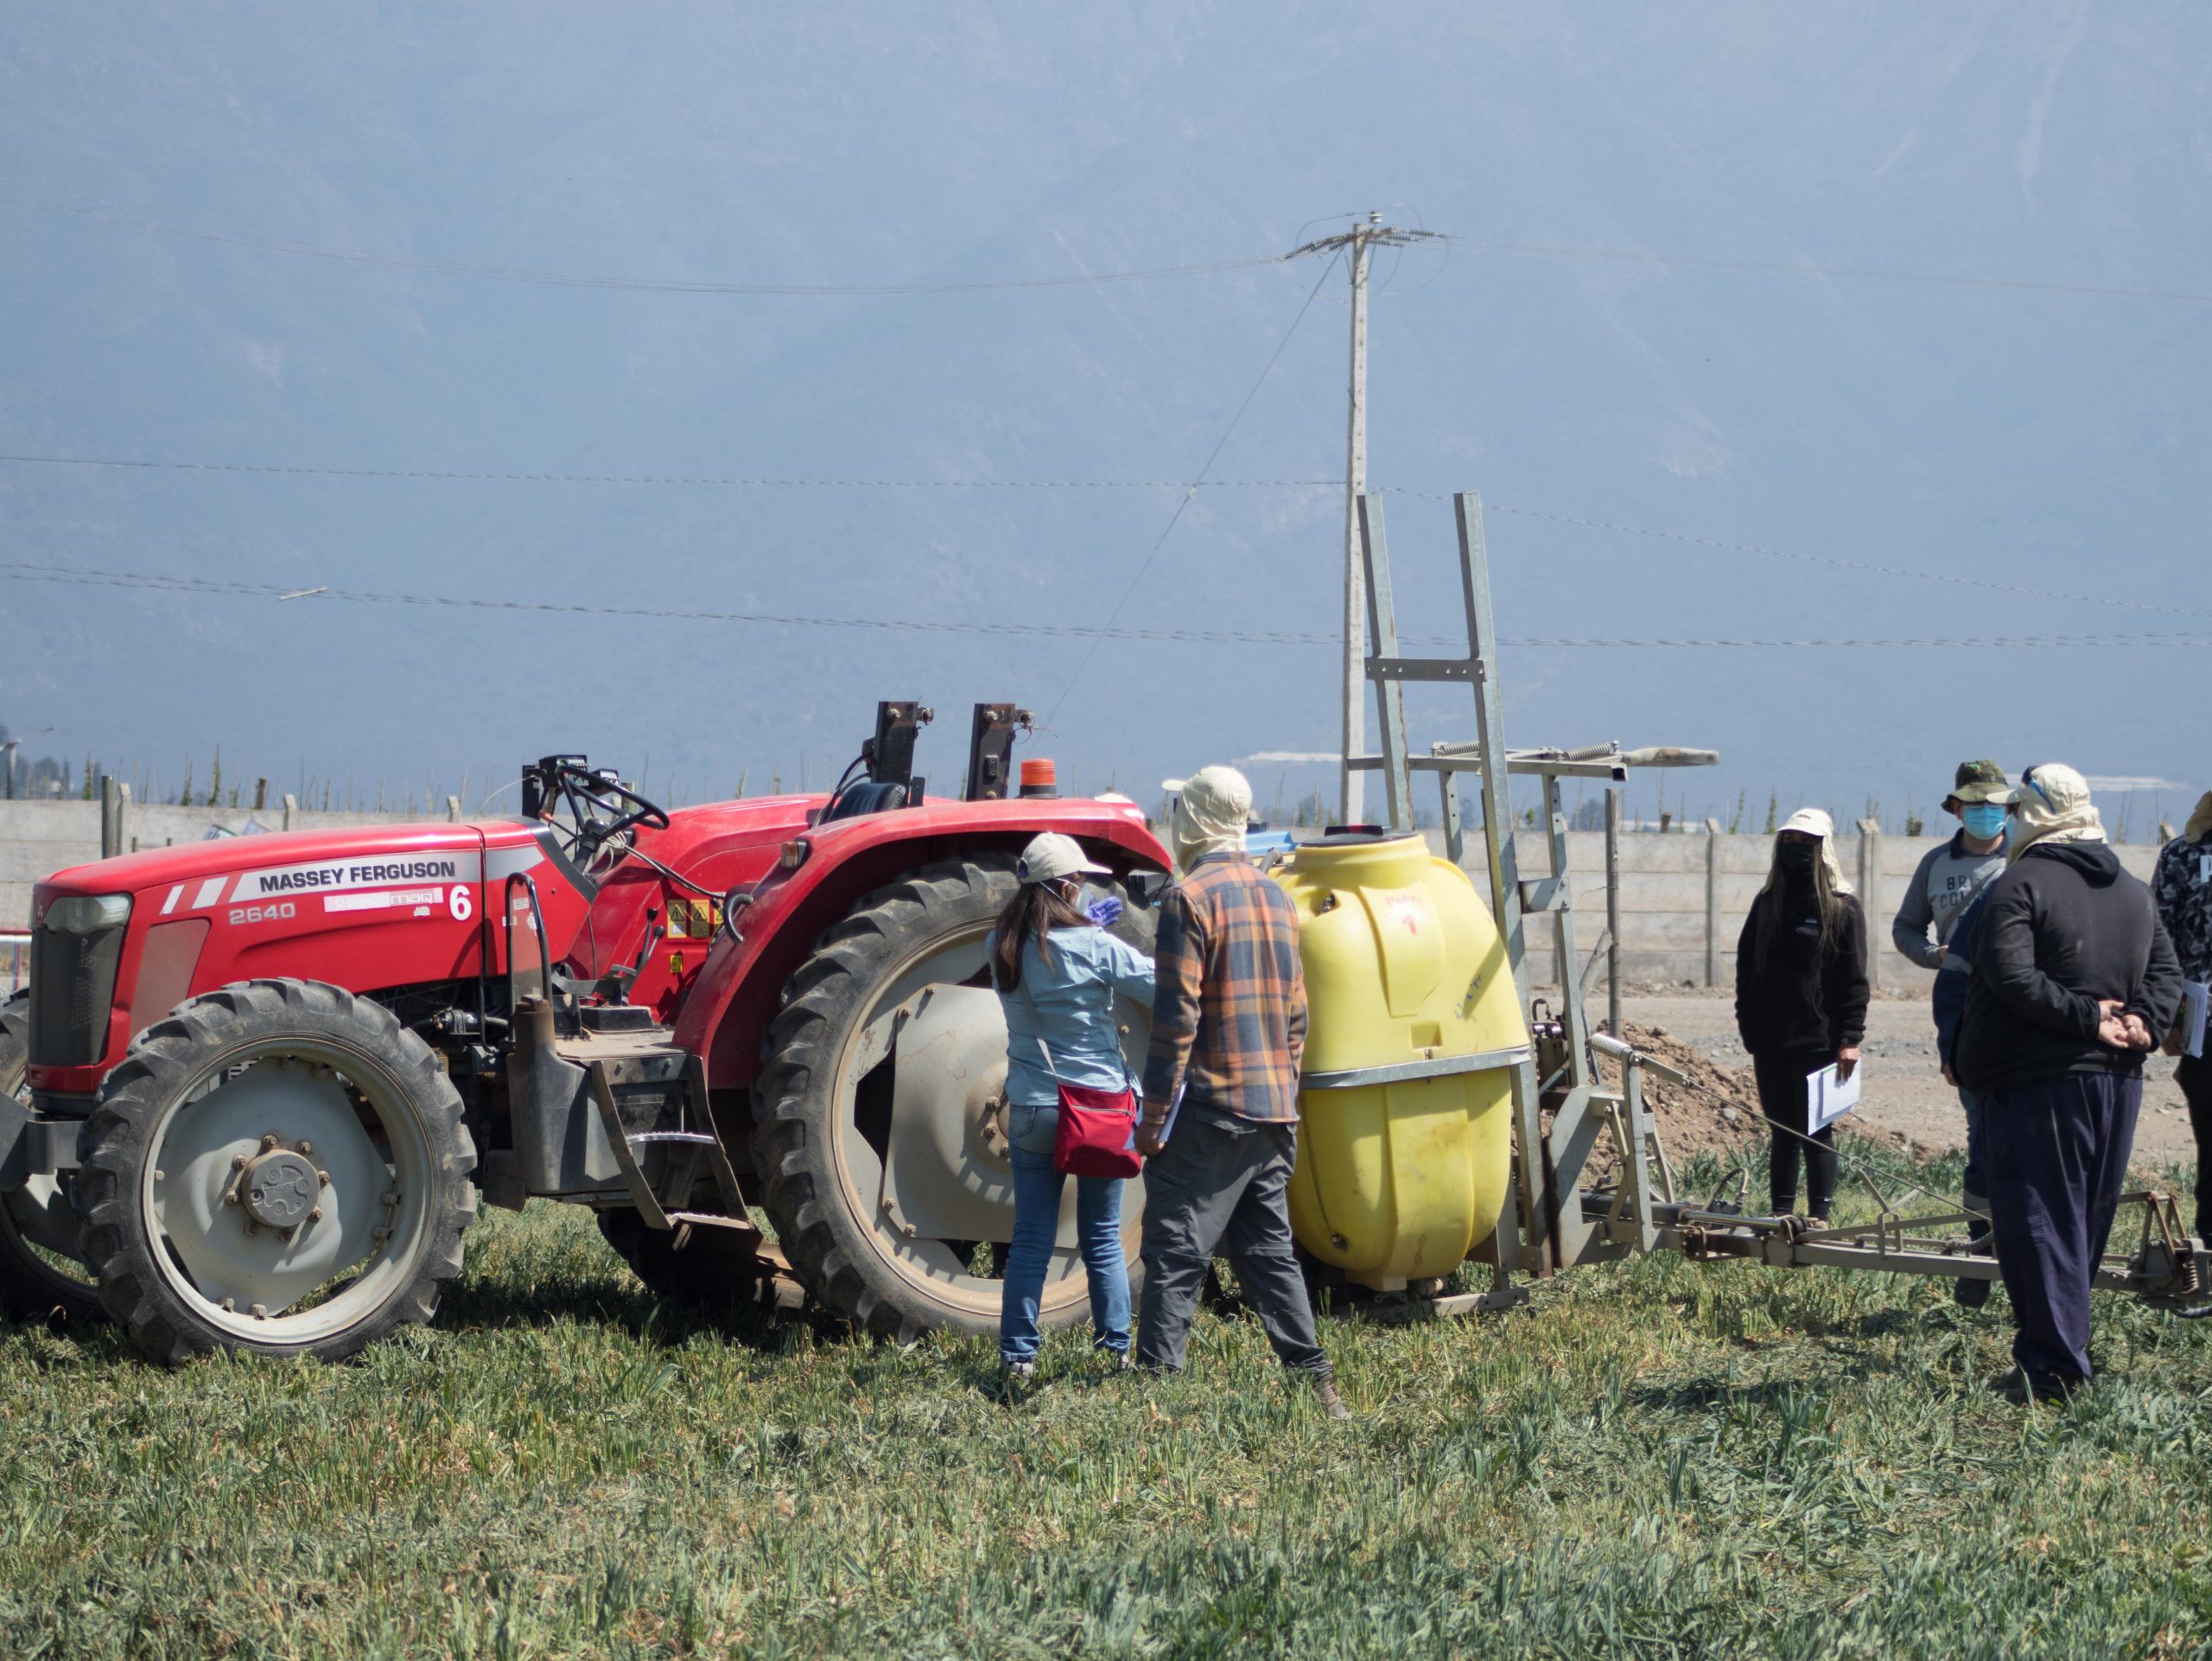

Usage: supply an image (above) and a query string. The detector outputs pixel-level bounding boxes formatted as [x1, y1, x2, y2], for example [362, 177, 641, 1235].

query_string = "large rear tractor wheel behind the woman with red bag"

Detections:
[752, 856, 1154, 1342]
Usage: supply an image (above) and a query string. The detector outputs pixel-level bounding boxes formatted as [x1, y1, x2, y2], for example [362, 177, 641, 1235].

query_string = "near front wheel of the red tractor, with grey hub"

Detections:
[78, 980, 475, 1363]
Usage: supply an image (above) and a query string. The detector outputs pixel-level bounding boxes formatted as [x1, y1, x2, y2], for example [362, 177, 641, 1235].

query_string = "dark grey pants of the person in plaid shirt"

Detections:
[1137, 1102, 1334, 1378]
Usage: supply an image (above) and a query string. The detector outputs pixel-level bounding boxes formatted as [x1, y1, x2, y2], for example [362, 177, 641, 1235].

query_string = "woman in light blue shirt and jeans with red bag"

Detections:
[988, 831, 1153, 1378]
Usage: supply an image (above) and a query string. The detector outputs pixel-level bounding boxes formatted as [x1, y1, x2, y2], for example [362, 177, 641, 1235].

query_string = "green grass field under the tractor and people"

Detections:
[0, 1141, 2212, 1657]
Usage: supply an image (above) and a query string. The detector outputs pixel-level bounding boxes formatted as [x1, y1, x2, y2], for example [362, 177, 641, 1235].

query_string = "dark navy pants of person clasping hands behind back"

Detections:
[1982, 1072, 2144, 1387]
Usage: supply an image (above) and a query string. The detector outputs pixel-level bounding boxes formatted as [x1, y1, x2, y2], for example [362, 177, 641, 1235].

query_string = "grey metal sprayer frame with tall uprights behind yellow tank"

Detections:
[1336, 491, 2212, 1316]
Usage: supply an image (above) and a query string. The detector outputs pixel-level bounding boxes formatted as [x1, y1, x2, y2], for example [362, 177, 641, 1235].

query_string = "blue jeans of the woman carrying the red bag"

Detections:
[998, 1106, 1128, 1363]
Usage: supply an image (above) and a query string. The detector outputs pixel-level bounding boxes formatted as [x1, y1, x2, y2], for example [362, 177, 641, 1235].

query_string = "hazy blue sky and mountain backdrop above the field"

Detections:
[0, 0, 2212, 834]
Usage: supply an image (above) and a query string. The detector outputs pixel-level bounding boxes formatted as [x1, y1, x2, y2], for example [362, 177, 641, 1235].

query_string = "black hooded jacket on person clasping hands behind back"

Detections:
[1953, 843, 2181, 1092]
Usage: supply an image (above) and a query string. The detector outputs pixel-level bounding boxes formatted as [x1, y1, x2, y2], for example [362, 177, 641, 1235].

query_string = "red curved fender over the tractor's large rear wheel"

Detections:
[675, 799, 1170, 1091]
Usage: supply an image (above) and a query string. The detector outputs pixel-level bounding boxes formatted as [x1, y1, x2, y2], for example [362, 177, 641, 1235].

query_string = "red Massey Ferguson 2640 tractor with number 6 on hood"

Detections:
[0, 703, 1168, 1363]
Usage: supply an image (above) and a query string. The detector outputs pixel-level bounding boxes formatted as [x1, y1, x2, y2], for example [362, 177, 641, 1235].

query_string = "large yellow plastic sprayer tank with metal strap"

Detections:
[1274, 831, 1529, 1292]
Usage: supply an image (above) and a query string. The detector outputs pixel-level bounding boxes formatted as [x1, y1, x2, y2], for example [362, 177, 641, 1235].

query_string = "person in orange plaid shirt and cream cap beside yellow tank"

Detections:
[1137, 767, 1350, 1417]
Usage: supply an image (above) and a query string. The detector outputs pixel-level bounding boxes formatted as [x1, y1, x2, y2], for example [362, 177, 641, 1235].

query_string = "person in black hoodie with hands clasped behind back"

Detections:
[1953, 763, 2181, 1397]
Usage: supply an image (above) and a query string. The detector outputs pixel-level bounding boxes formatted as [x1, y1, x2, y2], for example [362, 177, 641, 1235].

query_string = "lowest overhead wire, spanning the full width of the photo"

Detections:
[0, 559, 2212, 650]
